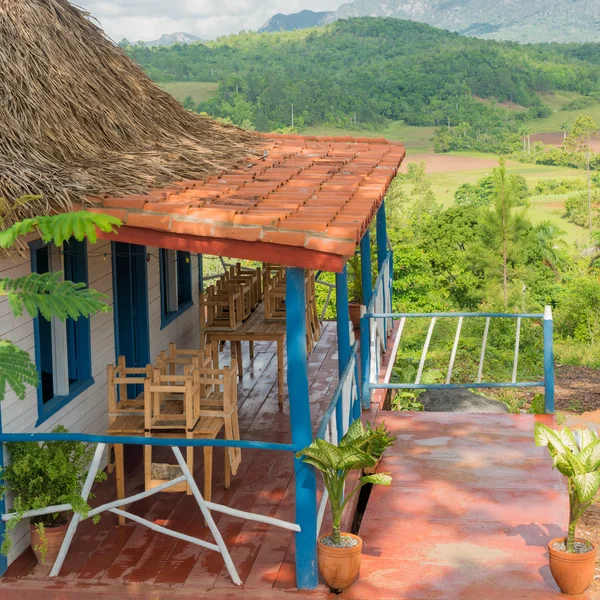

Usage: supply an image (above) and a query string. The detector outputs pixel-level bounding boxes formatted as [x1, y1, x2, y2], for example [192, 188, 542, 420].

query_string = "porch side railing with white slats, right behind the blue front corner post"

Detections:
[317, 343, 361, 536]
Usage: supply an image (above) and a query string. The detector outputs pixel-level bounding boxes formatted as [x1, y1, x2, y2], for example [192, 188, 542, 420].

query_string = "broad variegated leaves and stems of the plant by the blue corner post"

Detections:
[296, 419, 393, 546]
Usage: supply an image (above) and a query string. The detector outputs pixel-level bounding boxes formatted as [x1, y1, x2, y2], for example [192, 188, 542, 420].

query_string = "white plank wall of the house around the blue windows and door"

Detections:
[0, 242, 199, 564]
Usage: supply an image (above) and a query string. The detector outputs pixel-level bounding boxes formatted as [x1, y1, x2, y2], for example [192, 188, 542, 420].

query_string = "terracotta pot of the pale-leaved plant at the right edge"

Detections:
[548, 537, 596, 596]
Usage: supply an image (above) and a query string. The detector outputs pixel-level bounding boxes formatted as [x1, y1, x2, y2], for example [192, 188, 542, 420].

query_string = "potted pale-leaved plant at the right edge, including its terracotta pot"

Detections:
[535, 423, 600, 595]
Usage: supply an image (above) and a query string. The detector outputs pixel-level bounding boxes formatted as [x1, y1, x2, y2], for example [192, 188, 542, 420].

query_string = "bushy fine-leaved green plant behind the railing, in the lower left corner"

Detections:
[0, 425, 106, 560]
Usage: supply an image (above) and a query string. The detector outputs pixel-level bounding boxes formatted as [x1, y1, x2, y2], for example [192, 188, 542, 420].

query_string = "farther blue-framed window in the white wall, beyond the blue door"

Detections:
[160, 249, 194, 329]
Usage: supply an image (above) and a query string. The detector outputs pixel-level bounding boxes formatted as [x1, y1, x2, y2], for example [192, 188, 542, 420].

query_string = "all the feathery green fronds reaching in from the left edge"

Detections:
[0, 207, 121, 400]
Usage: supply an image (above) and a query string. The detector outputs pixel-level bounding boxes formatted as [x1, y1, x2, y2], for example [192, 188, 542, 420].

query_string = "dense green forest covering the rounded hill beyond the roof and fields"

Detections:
[125, 18, 600, 152]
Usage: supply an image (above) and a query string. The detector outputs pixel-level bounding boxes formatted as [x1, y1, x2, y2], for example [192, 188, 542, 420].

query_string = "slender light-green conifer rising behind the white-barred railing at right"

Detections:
[481, 159, 527, 309]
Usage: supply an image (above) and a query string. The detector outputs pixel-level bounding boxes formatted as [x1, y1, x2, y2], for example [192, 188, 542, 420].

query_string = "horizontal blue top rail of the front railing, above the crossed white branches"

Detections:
[0, 433, 300, 452]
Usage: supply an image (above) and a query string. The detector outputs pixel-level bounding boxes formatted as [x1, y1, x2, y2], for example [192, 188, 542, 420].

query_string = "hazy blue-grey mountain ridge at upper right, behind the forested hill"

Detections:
[259, 0, 600, 43]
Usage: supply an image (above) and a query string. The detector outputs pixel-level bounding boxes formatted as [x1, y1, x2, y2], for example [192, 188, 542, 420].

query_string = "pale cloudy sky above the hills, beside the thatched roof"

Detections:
[72, 0, 343, 42]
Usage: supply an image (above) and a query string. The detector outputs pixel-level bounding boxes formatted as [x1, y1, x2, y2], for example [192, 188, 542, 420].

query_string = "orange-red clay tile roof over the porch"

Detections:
[88, 135, 405, 270]
